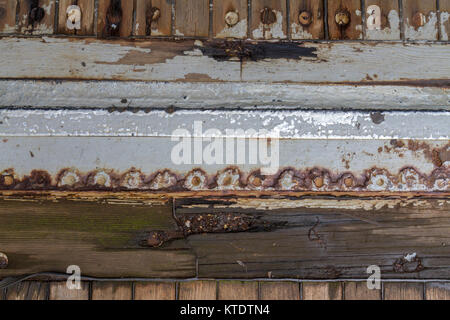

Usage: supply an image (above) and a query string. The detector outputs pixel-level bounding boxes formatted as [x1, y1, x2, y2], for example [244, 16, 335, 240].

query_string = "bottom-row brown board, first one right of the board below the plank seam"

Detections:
[218, 281, 259, 300]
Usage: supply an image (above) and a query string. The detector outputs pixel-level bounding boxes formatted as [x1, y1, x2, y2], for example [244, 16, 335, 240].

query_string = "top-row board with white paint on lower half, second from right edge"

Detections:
[403, 0, 438, 40]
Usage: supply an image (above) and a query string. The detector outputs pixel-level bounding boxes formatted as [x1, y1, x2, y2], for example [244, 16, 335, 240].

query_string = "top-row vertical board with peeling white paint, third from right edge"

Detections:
[364, 0, 401, 40]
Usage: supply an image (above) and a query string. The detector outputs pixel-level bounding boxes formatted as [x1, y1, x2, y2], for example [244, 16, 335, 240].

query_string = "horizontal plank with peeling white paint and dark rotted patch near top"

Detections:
[0, 38, 450, 87]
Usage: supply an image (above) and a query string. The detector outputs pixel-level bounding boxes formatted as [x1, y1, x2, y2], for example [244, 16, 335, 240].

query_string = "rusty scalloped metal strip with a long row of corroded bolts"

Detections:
[0, 165, 450, 192]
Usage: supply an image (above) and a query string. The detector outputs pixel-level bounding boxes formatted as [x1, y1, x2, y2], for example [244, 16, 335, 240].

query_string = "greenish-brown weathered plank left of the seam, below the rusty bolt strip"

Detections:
[0, 202, 195, 278]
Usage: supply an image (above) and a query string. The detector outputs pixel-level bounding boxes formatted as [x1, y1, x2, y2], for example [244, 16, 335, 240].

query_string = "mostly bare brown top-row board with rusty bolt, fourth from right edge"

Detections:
[328, 0, 363, 40]
